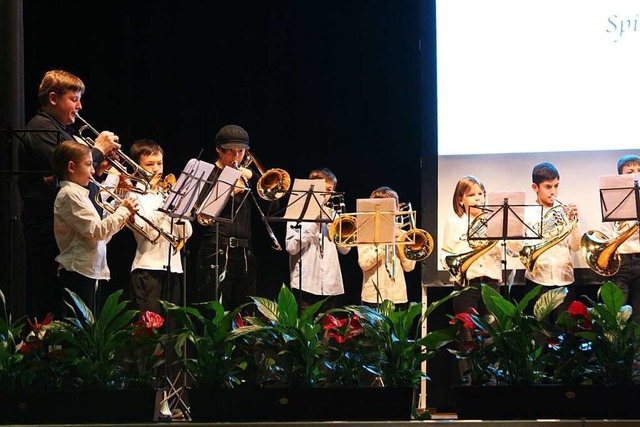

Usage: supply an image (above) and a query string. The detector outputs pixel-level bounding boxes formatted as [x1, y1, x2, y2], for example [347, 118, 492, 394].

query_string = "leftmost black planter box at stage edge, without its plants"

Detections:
[0, 389, 156, 424]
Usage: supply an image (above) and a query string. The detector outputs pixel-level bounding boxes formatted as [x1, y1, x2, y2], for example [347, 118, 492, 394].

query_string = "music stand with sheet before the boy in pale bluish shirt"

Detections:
[278, 178, 343, 307]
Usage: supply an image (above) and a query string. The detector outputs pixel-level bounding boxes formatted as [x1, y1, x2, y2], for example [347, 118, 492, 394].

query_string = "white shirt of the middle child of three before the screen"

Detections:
[524, 202, 582, 286]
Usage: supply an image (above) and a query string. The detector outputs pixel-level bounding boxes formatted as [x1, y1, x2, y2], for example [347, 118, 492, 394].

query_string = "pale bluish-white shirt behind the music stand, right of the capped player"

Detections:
[285, 222, 351, 295]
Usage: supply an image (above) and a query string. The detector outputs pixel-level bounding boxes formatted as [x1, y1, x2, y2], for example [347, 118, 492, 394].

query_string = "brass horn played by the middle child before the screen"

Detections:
[518, 203, 578, 272]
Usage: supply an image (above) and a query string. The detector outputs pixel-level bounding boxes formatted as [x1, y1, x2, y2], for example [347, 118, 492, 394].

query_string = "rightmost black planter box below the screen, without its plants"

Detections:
[454, 385, 640, 420]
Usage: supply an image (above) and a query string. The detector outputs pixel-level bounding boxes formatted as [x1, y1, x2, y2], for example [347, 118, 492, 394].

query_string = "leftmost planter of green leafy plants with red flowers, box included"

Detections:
[0, 290, 163, 423]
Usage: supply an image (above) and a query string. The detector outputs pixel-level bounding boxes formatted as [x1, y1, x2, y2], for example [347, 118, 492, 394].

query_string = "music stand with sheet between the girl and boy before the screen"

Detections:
[467, 191, 543, 292]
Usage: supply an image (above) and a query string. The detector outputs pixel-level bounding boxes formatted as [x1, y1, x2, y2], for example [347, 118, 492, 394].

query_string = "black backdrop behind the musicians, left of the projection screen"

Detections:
[2, 0, 451, 410]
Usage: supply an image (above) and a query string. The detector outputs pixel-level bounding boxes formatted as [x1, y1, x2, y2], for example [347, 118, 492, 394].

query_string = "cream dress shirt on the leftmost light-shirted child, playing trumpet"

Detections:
[53, 181, 130, 280]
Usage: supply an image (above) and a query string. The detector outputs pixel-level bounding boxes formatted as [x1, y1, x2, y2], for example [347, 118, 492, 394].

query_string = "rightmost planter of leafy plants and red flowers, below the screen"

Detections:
[451, 282, 640, 419]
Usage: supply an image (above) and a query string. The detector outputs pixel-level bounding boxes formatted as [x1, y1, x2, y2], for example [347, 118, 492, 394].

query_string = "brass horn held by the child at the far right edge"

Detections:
[580, 221, 640, 277]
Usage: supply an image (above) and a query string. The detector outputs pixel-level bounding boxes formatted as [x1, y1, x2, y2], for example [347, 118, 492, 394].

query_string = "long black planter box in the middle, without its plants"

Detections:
[188, 387, 414, 422]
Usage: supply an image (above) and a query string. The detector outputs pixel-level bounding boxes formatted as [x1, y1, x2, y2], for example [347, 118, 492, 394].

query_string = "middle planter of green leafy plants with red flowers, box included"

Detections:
[178, 286, 455, 421]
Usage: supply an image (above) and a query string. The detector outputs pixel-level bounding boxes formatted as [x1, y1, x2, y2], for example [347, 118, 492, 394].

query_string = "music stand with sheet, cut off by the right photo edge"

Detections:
[600, 174, 640, 222]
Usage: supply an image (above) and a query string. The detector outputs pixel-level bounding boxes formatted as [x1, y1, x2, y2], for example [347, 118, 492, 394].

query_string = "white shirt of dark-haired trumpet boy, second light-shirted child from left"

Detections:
[130, 191, 193, 273]
